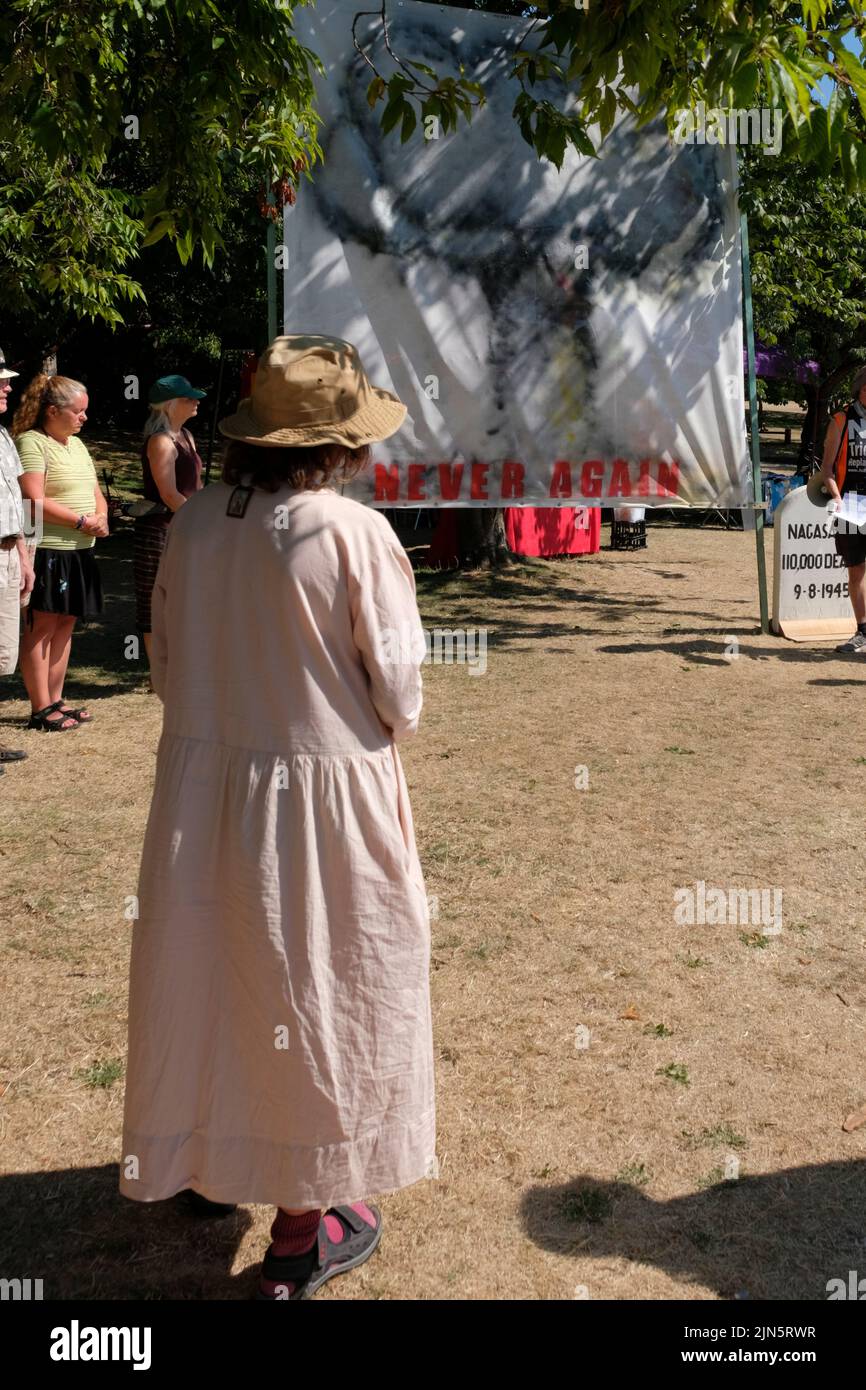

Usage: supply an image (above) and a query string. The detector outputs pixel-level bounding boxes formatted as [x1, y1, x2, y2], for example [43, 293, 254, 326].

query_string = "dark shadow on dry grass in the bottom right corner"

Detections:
[521, 1159, 866, 1300]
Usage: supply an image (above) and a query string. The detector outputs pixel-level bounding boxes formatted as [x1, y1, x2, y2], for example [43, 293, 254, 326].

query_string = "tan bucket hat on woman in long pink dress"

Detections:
[220, 334, 407, 449]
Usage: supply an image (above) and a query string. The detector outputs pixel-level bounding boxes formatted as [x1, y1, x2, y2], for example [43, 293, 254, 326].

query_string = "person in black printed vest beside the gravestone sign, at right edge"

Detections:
[816, 367, 866, 656]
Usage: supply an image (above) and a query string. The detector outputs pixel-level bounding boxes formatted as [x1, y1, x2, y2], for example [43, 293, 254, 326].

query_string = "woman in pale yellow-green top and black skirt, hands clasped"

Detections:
[13, 374, 108, 733]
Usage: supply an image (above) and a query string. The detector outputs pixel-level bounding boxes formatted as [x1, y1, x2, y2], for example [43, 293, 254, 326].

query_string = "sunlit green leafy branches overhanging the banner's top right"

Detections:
[368, 0, 866, 179]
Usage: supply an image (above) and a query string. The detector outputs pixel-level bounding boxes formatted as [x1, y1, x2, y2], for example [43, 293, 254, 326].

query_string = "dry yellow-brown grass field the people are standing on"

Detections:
[0, 503, 866, 1300]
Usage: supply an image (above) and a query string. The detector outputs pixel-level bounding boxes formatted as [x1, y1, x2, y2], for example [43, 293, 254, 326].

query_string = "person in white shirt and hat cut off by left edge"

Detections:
[0, 348, 33, 776]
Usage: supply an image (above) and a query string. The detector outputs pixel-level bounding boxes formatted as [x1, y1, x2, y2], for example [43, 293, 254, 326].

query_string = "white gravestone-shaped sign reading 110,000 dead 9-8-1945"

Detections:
[773, 485, 856, 642]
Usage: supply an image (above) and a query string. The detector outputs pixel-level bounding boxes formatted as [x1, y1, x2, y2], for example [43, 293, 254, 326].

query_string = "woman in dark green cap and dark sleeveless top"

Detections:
[133, 375, 206, 675]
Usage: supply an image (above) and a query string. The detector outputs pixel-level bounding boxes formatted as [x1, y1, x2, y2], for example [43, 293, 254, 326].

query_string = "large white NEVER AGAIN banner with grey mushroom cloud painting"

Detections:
[285, 0, 753, 507]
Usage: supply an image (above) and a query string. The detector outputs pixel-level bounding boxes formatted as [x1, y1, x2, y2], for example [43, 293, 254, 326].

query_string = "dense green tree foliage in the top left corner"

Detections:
[0, 0, 321, 322]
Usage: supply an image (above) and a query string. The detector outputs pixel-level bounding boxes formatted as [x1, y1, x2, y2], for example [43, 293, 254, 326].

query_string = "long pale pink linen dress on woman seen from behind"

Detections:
[120, 482, 435, 1208]
